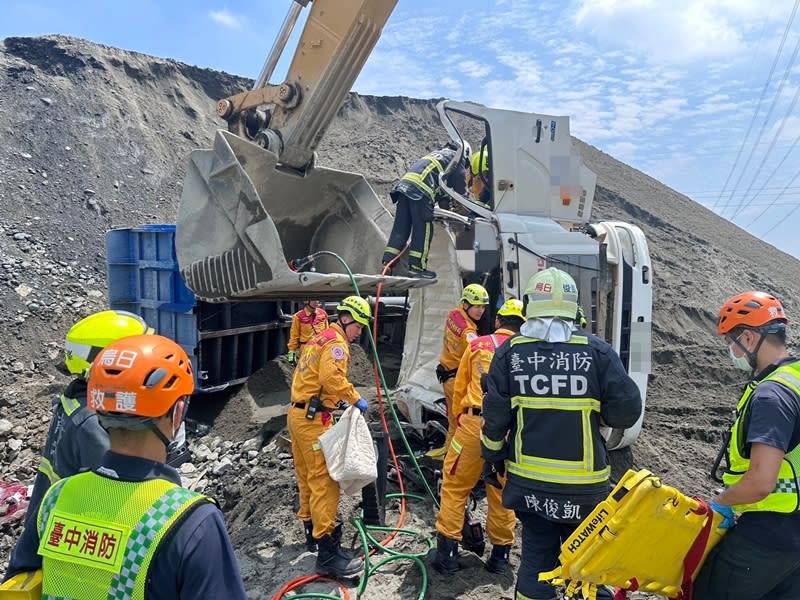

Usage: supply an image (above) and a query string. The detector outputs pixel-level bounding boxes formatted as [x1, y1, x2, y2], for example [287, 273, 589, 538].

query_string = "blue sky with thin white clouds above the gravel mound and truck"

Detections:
[0, 0, 800, 258]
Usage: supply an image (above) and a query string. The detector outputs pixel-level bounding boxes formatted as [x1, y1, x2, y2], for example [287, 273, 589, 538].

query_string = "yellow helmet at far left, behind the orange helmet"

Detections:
[64, 310, 154, 377]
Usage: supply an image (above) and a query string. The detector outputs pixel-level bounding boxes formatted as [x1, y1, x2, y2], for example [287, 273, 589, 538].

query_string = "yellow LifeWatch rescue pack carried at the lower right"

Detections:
[539, 469, 725, 600]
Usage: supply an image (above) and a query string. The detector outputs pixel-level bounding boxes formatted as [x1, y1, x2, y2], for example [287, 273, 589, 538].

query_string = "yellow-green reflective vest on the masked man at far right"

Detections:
[722, 361, 800, 513]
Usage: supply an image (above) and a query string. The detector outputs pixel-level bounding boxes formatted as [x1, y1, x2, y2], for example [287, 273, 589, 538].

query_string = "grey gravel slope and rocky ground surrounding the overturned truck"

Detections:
[0, 37, 800, 600]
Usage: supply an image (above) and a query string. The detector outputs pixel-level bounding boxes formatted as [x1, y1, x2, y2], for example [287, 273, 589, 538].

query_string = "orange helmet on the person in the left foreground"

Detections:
[87, 335, 194, 417]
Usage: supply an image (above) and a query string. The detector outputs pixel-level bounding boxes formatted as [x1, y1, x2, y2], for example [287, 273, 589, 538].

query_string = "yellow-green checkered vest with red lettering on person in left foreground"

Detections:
[37, 472, 213, 600]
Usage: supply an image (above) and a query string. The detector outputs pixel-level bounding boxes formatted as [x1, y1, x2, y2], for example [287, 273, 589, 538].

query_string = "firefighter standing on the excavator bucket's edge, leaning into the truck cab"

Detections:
[383, 142, 472, 279]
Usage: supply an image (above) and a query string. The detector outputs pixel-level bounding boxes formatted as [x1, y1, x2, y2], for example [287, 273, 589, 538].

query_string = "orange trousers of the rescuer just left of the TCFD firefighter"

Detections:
[436, 413, 517, 546]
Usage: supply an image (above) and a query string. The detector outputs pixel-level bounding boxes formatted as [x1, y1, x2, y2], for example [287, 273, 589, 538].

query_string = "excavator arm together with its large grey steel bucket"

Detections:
[175, 0, 430, 302]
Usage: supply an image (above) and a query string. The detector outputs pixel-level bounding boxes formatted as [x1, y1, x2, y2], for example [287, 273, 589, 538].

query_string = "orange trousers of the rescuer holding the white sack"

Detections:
[286, 406, 340, 539]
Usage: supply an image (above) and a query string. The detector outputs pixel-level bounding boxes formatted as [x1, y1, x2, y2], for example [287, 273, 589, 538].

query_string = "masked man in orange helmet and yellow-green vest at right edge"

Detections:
[693, 292, 800, 600]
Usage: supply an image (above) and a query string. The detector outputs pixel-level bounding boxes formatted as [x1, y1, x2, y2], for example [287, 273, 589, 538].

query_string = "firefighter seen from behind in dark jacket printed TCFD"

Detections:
[481, 268, 642, 600]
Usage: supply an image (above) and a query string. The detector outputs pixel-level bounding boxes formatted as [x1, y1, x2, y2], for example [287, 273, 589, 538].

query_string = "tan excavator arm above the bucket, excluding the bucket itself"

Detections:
[217, 0, 397, 169]
